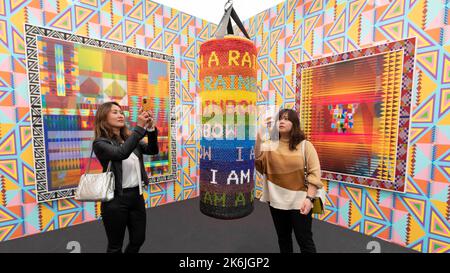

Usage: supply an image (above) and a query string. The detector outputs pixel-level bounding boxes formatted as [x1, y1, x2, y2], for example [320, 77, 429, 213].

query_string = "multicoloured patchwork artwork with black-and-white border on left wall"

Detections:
[25, 25, 177, 202]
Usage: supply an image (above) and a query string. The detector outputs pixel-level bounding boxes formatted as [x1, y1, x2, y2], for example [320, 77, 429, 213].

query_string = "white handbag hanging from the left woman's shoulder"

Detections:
[75, 150, 115, 202]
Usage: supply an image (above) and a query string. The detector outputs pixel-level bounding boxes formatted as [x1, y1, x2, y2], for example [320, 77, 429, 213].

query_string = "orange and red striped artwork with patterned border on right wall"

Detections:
[296, 38, 415, 192]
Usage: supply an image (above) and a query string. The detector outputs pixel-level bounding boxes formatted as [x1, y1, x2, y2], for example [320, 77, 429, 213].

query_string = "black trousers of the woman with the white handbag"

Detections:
[101, 187, 147, 253]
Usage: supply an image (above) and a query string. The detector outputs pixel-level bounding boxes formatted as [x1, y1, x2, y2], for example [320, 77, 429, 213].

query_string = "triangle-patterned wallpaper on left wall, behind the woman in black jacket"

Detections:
[0, 0, 216, 241]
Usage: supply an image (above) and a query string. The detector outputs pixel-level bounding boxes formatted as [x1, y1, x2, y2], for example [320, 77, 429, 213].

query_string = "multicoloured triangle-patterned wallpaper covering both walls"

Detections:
[0, 0, 450, 253]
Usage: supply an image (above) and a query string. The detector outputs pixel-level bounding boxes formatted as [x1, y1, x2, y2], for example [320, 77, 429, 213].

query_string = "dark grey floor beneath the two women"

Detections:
[0, 198, 414, 253]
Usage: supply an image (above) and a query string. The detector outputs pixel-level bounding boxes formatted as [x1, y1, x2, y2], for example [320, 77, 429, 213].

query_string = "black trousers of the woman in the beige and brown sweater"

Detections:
[269, 206, 317, 253]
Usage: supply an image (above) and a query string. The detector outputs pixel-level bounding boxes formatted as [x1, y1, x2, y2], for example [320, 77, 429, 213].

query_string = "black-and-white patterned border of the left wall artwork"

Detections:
[25, 24, 177, 202]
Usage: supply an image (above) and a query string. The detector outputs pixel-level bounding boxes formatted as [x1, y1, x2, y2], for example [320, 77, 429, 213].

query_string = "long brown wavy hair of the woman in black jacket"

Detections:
[94, 101, 130, 141]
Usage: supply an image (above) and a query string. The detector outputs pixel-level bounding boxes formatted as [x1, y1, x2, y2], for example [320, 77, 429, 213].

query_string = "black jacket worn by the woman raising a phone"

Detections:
[93, 126, 159, 195]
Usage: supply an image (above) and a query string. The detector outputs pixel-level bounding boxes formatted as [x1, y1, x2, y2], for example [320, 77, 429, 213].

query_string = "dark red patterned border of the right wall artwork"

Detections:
[296, 38, 416, 192]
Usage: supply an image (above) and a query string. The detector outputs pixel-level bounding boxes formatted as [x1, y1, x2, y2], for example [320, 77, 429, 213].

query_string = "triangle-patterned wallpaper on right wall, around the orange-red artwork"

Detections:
[244, 0, 450, 253]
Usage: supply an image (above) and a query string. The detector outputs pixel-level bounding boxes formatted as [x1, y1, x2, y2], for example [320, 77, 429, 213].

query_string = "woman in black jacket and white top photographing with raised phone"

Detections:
[93, 102, 159, 253]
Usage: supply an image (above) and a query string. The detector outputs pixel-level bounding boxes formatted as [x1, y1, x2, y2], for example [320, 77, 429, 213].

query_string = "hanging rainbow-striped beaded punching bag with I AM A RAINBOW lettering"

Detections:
[199, 3, 257, 219]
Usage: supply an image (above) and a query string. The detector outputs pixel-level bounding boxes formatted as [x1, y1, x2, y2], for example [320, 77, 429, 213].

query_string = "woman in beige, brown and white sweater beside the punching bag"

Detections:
[255, 109, 323, 253]
